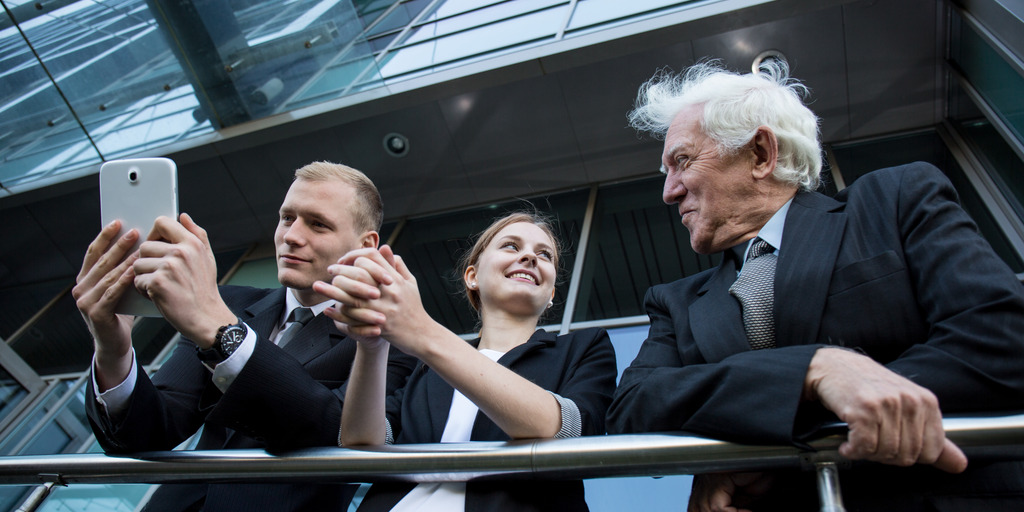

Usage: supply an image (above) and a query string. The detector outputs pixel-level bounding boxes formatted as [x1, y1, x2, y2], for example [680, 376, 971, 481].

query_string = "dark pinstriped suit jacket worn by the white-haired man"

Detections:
[608, 163, 1024, 502]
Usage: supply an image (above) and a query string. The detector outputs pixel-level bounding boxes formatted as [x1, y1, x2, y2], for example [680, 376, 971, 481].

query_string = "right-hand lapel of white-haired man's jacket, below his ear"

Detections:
[775, 193, 846, 346]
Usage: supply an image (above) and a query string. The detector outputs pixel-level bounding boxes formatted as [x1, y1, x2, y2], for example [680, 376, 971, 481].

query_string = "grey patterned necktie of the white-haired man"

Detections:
[729, 237, 777, 350]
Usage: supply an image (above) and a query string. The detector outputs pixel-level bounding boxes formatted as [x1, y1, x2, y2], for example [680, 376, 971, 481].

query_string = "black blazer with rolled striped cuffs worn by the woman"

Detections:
[359, 329, 615, 512]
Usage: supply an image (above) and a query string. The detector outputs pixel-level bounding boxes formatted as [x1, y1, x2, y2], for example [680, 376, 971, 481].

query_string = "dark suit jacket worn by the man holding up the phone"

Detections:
[86, 287, 415, 511]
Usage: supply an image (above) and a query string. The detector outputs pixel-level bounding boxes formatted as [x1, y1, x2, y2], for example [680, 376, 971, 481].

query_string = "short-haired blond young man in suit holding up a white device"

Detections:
[73, 162, 415, 512]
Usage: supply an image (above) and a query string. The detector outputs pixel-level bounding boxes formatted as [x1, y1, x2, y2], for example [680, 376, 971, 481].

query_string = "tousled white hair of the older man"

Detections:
[629, 59, 821, 190]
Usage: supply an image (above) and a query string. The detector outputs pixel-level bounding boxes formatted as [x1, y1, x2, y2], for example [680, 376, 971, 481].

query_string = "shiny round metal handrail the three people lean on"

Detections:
[0, 415, 1024, 484]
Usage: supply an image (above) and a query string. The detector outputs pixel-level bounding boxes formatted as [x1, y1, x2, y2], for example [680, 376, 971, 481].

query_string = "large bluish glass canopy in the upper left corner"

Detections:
[0, 0, 403, 186]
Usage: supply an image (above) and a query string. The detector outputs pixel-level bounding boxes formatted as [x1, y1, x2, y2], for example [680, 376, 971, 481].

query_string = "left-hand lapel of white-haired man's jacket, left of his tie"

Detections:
[688, 255, 751, 362]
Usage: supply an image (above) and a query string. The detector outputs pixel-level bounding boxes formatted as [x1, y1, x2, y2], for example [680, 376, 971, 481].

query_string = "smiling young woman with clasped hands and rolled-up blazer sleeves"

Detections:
[316, 213, 615, 512]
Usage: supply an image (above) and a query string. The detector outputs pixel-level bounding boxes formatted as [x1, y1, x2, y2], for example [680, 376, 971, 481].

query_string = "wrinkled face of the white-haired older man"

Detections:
[662, 105, 760, 254]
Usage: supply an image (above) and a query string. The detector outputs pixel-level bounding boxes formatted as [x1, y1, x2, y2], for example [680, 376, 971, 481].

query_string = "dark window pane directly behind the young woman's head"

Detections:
[394, 190, 588, 334]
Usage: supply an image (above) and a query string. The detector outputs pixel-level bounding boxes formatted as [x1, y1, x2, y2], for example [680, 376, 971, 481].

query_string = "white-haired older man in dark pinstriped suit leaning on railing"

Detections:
[608, 63, 1024, 511]
